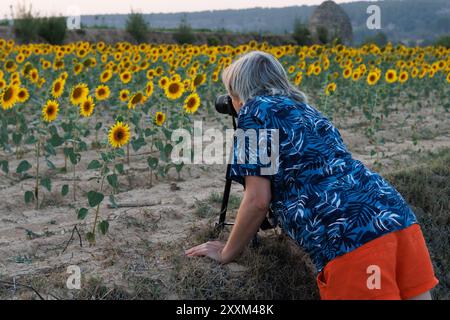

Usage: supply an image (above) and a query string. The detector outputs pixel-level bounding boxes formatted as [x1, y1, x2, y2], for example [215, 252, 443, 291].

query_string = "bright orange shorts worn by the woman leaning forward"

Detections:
[317, 224, 439, 300]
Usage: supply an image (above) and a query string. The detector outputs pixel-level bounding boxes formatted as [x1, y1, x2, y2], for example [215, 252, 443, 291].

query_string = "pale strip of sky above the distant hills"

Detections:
[0, 0, 370, 19]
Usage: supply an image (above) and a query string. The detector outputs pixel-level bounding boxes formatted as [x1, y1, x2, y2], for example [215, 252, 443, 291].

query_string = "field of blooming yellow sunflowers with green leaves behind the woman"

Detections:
[0, 39, 450, 243]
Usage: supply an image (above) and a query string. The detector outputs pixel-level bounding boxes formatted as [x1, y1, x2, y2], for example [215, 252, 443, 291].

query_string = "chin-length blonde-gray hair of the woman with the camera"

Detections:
[222, 51, 307, 103]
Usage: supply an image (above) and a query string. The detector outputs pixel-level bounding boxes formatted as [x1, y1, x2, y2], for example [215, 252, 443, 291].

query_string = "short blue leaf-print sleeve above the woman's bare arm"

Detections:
[228, 101, 278, 185]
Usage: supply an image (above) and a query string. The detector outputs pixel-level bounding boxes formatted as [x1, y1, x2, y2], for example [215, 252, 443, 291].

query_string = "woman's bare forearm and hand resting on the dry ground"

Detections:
[186, 176, 271, 263]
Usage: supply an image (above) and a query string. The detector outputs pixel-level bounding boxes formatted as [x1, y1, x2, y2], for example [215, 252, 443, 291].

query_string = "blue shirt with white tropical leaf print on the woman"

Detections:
[229, 95, 417, 272]
